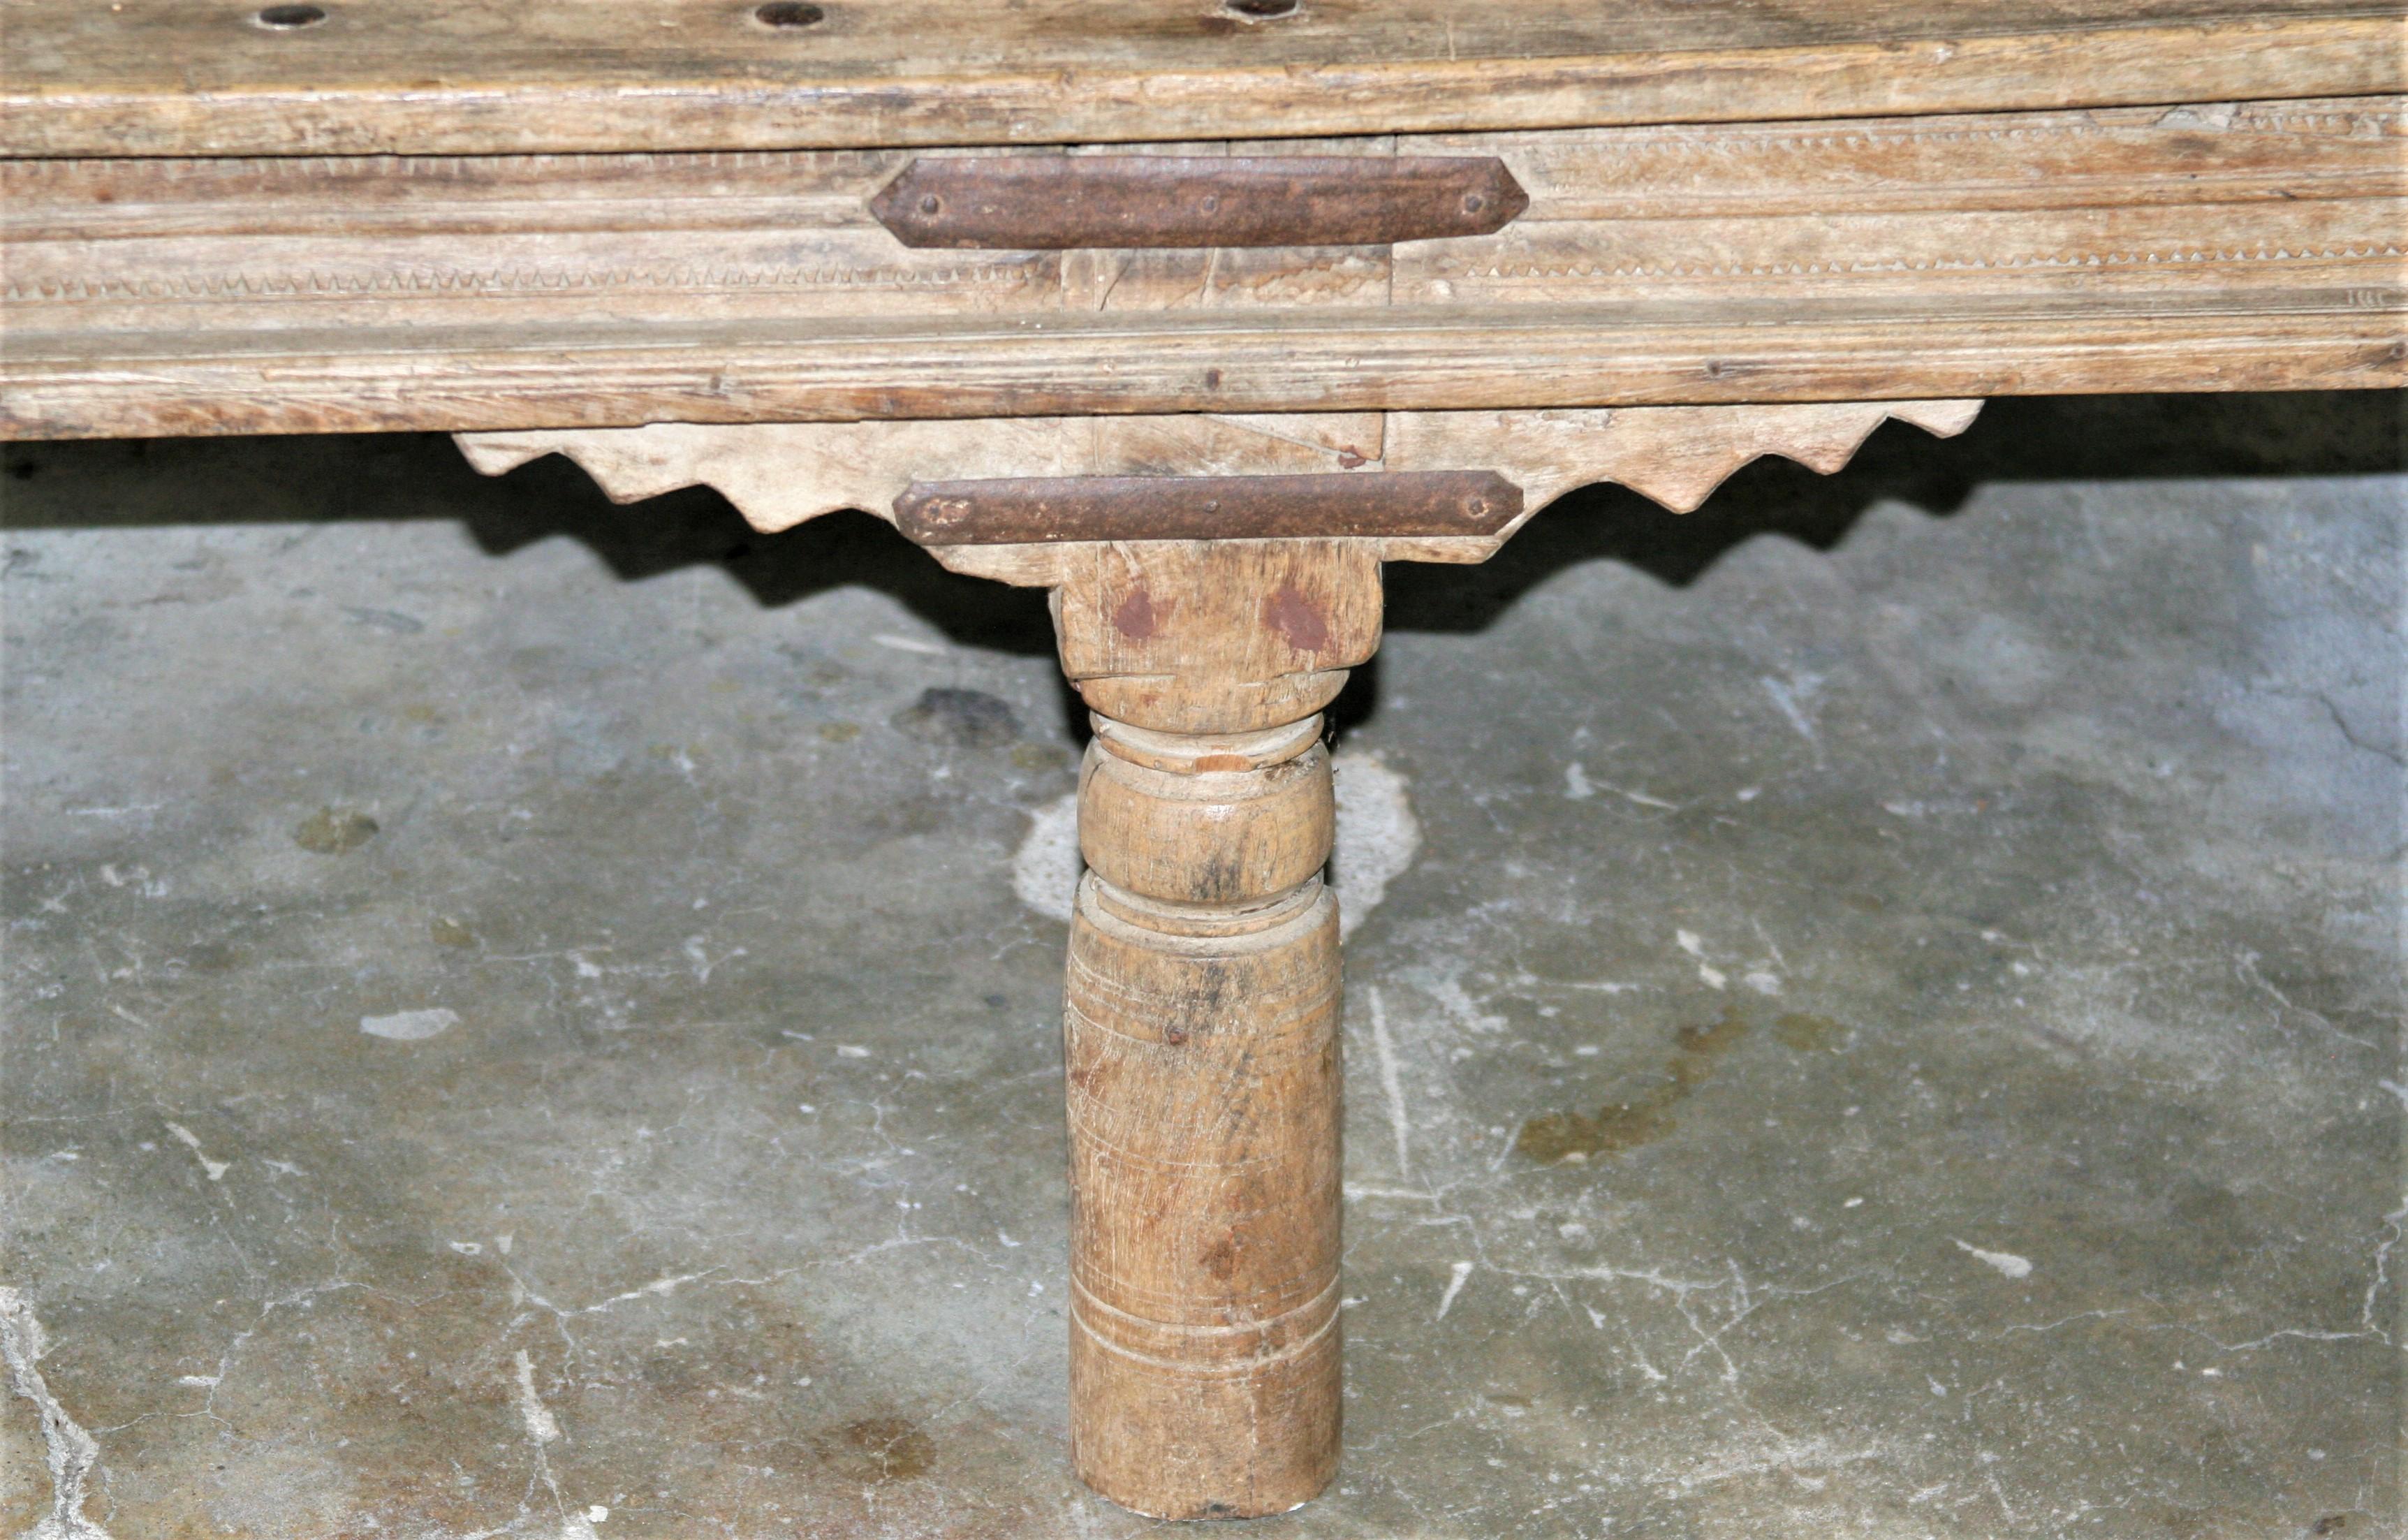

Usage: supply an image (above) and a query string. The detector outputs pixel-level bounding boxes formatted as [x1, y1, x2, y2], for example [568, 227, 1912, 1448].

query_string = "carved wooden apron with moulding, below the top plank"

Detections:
[0, 96, 2408, 438]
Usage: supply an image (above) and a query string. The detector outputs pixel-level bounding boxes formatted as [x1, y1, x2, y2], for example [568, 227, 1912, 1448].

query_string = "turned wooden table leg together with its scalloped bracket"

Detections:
[462, 402, 1979, 1518]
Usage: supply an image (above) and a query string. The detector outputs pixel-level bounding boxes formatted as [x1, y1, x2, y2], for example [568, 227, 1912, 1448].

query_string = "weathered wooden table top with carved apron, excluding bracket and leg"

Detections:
[0, 0, 2403, 436]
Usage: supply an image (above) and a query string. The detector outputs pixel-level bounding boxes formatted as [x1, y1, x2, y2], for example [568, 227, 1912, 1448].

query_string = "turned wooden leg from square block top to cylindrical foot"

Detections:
[1055, 541, 1380, 1518]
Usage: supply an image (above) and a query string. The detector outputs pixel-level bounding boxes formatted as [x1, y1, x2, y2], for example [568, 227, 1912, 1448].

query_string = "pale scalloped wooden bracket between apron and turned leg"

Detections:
[455, 402, 1982, 585]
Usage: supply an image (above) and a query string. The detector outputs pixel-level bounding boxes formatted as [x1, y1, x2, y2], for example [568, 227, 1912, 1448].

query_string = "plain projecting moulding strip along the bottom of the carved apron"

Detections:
[0, 286, 2408, 438]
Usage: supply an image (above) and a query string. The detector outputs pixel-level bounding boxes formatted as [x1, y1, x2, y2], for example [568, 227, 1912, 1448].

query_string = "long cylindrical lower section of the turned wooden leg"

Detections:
[1064, 871, 1339, 1518]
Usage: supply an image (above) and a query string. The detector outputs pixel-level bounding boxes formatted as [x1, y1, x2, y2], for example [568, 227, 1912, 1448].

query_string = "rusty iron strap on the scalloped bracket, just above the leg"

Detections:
[896, 471, 1522, 546]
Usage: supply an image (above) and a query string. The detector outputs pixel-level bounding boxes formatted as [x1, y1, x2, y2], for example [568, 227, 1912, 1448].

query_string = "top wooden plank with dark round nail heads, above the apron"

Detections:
[0, 0, 2408, 156]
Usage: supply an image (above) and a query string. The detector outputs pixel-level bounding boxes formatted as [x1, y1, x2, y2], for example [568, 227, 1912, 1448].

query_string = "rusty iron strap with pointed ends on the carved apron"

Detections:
[869, 154, 1529, 250]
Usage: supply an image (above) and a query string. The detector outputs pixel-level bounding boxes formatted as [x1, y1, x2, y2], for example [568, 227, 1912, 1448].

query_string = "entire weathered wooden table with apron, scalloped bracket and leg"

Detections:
[0, 0, 2408, 1516]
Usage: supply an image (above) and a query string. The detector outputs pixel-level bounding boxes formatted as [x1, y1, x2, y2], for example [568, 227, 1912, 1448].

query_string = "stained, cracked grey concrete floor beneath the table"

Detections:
[0, 397, 2408, 1540]
